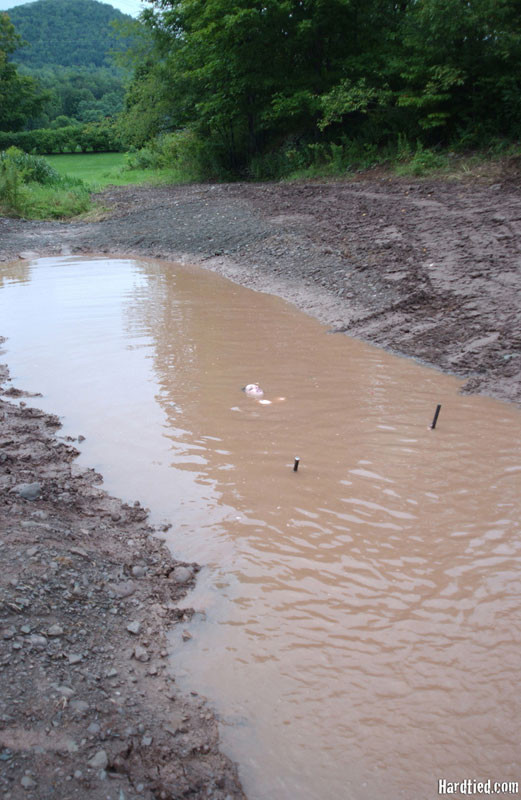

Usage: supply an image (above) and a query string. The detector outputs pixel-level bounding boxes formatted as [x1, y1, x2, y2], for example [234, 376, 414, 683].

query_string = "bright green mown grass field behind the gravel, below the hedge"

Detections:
[45, 153, 171, 191]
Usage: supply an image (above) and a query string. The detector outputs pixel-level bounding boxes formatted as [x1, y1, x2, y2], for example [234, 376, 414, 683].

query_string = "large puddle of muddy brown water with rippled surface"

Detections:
[0, 258, 521, 800]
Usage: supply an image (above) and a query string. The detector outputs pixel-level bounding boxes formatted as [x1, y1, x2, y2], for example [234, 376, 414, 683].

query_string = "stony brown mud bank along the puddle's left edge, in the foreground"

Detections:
[0, 358, 244, 800]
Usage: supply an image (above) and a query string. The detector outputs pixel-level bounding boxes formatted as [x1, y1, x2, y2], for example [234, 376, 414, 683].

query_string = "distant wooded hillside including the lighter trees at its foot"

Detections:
[0, 0, 135, 131]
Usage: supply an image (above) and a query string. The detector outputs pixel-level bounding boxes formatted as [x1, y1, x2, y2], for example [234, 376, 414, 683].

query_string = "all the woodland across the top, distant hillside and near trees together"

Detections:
[0, 0, 521, 177]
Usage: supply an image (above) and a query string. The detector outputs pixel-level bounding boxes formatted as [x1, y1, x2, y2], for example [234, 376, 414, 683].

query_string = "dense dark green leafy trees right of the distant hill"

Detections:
[122, 0, 521, 176]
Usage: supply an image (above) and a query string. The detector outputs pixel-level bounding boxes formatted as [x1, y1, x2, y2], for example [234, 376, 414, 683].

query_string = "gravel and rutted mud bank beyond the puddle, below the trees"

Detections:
[0, 175, 521, 403]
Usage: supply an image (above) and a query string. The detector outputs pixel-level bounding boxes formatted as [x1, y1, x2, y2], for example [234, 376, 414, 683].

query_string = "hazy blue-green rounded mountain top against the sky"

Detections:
[7, 0, 132, 69]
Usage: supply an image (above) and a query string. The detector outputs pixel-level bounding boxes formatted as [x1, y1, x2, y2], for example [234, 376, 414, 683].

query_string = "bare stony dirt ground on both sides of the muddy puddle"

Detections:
[0, 176, 521, 800]
